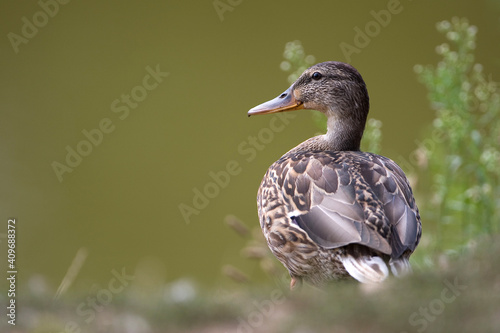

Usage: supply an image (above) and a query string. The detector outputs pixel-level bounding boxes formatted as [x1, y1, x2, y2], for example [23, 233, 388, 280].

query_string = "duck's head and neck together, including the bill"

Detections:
[248, 61, 370, 150]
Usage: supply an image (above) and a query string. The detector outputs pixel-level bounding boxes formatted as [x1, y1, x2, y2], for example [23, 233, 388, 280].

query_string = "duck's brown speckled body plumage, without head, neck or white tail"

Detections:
[257, 151, 422, 282]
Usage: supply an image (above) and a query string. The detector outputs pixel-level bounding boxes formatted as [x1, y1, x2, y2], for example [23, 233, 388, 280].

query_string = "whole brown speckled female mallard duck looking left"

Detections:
[248, 61, 422, 287]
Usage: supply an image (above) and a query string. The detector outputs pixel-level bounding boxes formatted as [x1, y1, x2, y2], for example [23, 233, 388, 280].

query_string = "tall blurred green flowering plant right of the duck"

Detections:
[415, 18, 500, 260]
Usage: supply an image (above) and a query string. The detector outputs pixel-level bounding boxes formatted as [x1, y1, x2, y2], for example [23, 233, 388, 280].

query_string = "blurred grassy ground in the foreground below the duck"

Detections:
[1, 231, 500, 333]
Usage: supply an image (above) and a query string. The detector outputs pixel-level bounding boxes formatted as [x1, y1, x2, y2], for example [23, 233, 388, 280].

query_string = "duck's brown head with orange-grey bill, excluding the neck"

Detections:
[248, 61, 369, 122]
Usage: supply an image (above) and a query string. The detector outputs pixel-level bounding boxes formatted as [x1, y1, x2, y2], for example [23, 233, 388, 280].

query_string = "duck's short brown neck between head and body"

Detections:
[324, 117, 365, 151]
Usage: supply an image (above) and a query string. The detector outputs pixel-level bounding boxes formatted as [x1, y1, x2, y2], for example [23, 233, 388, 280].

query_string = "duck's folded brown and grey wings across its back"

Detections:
[274, 152, 421, 259]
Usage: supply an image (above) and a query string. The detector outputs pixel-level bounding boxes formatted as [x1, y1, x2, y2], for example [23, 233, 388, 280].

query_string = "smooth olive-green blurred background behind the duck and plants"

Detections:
[0, 0, 500, 293]
